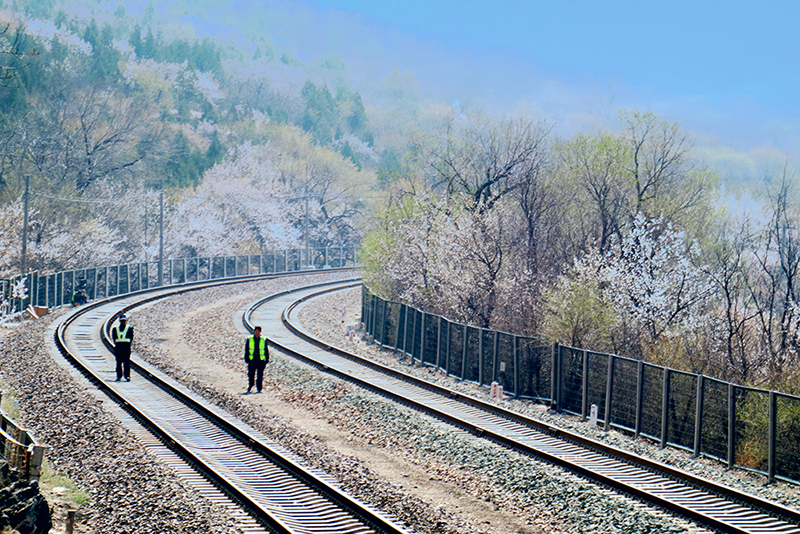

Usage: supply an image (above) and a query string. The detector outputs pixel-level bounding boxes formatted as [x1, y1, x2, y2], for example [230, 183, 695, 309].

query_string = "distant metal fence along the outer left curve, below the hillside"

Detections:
[0, 247, 355, 316]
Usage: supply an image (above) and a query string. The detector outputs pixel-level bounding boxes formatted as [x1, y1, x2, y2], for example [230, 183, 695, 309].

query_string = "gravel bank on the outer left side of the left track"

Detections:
[0, 312, 244, 534]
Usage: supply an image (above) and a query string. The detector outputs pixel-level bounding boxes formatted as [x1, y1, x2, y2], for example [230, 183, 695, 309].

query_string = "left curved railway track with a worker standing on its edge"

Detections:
[55, 271, 408, 534]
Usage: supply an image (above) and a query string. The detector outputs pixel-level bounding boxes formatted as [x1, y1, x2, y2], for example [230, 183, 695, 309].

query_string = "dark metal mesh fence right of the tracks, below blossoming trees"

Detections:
[362, 286, 800, 488]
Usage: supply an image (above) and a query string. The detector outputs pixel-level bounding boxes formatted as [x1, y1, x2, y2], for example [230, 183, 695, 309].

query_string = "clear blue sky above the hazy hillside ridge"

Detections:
[309, 0, 800, 109]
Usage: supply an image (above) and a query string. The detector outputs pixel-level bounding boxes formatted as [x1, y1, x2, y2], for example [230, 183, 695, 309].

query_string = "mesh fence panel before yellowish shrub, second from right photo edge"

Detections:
[734, 386, 769, 472]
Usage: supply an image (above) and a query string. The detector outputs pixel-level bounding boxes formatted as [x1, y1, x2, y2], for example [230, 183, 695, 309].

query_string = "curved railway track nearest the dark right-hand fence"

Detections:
[248, 283, 800, 534]
